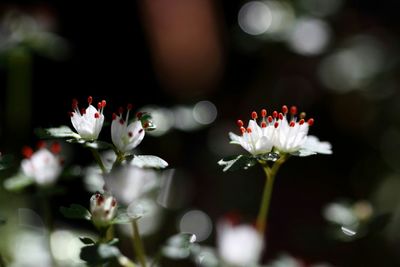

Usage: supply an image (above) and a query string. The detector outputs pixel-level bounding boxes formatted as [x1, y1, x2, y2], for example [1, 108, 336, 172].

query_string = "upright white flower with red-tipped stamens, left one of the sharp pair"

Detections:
[70, 96, 106, 140]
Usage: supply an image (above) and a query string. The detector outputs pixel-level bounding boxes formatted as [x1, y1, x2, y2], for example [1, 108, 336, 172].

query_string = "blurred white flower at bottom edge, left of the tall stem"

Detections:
[217, 221, 264, 267]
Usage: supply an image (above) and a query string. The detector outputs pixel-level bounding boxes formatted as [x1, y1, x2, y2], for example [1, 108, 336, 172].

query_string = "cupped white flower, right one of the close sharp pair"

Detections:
[111, 105, 145, 153]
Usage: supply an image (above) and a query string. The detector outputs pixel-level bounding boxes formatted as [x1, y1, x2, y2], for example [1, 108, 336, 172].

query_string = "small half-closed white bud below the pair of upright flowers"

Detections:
[90, 192, 117, 228]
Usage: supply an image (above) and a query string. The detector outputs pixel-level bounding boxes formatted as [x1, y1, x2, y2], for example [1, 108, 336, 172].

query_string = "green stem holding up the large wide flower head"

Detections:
[256, 155, 288, 236]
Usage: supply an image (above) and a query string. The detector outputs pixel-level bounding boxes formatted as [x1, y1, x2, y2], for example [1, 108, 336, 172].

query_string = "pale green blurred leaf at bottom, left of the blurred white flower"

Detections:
[161, 233, 196, 259]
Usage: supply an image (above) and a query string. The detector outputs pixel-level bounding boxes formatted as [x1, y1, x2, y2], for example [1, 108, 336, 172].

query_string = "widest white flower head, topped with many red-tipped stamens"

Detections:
[229, 105, 332, 156]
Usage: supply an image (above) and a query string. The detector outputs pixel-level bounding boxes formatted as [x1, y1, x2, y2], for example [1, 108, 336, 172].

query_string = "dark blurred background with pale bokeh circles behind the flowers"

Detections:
[0, 0, 400, 266]
